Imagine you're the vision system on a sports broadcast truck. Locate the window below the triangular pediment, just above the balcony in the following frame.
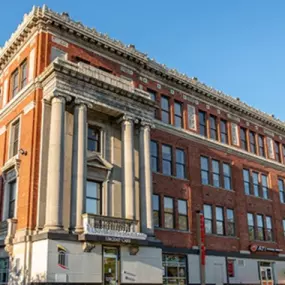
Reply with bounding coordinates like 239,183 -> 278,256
86,180 -> 101,215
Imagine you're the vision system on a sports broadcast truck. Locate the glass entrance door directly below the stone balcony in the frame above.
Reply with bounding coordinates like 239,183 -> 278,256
103,247 -> 118,285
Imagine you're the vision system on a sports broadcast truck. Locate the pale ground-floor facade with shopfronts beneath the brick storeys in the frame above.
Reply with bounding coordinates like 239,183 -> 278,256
0,235 -> 285,285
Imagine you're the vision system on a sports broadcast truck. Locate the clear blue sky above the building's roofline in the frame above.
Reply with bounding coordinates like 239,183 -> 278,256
0,0 -> 285,121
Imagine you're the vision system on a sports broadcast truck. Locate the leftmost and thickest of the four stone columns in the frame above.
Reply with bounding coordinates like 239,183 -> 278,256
45,96 -> 66,230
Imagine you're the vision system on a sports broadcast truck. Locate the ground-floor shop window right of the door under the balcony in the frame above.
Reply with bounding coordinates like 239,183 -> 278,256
162,254 -> 187,285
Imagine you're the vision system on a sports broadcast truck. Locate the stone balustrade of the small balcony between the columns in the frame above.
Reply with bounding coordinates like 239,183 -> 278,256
83,214 -> 147,240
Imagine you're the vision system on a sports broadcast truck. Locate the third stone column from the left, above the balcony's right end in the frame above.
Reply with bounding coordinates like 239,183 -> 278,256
122,116 -> 135,219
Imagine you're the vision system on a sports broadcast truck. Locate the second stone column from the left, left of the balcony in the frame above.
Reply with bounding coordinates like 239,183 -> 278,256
70,100 -> 87,232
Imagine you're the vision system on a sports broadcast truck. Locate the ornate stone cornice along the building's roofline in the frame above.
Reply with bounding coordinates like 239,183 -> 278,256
0,5 -> 285,132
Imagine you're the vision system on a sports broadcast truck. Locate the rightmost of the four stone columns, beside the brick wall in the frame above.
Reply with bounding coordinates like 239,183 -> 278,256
139,122 -> 154,236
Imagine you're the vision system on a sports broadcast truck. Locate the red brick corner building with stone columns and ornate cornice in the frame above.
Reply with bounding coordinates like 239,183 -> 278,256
0,6 -> 285,284
